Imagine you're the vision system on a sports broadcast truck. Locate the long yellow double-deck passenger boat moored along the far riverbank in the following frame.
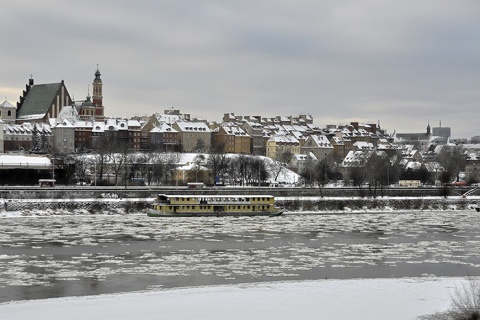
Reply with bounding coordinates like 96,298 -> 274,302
148,194 -> 284,217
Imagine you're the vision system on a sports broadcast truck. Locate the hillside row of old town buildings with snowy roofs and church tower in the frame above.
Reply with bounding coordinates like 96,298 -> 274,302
0,67 -> 473,185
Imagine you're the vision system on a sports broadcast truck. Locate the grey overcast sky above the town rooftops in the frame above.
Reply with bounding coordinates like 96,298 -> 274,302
0,0 -> 480,138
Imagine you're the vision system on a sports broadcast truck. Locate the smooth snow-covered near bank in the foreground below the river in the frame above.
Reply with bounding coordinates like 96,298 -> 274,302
0,278 -> 466,320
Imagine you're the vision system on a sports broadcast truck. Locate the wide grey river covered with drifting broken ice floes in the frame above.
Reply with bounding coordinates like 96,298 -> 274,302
0,210 -> 480,302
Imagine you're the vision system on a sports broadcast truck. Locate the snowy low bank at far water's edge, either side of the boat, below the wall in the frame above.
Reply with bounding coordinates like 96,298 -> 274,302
0,196 -> 480,216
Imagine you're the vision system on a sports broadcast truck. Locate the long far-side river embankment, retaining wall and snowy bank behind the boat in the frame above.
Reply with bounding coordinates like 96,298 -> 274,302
0,187 -> 480,214
